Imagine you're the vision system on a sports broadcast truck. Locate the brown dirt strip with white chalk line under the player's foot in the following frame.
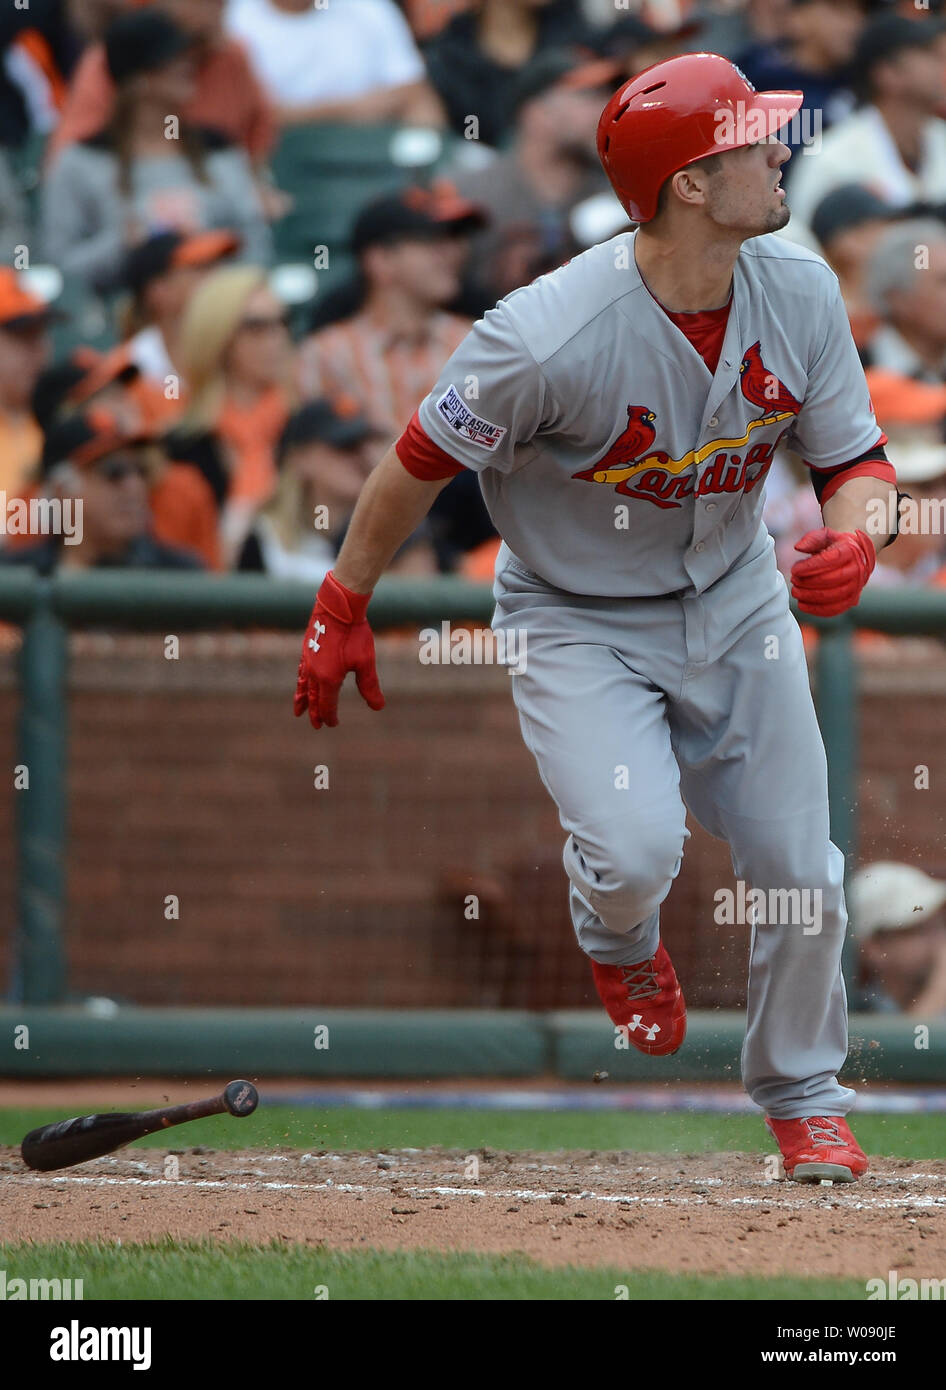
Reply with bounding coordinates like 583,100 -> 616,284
0,1148 -> 946,1279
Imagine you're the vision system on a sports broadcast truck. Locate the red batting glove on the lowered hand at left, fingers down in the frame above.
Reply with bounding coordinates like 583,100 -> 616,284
292,570 -> 385,728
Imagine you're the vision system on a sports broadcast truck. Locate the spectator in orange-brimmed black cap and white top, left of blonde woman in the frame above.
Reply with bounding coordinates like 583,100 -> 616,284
121,231 -> 240,403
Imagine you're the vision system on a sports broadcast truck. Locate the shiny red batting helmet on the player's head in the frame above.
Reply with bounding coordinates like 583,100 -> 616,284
597,53 -> 804,222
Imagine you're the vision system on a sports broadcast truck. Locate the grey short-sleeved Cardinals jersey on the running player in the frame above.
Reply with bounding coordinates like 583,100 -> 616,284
418,234 -> 881,598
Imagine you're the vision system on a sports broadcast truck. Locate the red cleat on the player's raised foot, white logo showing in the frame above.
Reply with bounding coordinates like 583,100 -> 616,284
592,941 -> 686,1056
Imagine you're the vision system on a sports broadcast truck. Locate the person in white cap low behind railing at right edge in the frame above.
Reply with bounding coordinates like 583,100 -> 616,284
847,859 -> 946,1019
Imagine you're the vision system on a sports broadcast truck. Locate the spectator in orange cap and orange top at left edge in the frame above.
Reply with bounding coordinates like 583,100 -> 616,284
0,267 -> 54,514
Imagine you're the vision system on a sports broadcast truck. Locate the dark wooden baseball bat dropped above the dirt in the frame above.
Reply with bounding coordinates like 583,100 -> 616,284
19,1081 -> 260,1173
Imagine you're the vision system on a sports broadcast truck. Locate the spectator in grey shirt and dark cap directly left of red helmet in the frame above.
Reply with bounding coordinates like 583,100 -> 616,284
454,50 -> 616,303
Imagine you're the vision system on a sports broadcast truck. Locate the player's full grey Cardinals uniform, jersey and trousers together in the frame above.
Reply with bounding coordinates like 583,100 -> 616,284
405,234 -> 882,1119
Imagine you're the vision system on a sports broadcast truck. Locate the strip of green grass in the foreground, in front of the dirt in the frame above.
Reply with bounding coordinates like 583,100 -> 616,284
0,1240 -> 865,1301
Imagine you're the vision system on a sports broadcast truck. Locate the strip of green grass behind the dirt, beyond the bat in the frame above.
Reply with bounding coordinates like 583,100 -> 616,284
0,1105 -> 946,1159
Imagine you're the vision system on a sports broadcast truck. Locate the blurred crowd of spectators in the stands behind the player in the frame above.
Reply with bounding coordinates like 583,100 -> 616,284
0,0 -> 946,585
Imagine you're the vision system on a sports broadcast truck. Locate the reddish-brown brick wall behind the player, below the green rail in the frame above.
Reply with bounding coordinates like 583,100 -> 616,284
0,634 -> 946,1008
